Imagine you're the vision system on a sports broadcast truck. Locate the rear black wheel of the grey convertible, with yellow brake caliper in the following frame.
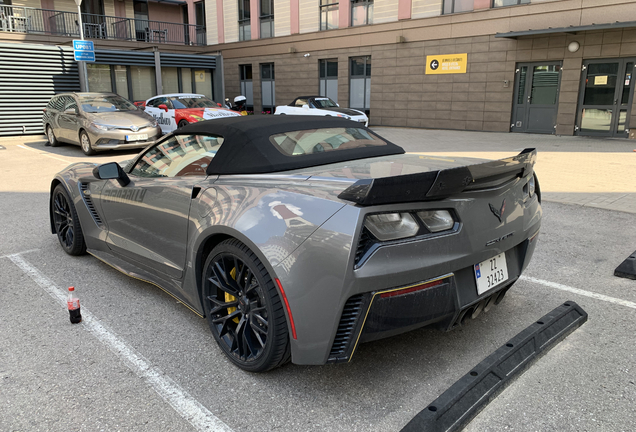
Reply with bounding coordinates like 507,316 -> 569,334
203,239 -> 290,372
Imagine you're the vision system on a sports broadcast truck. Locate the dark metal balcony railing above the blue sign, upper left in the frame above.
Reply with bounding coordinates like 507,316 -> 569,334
0,6 -> 206,45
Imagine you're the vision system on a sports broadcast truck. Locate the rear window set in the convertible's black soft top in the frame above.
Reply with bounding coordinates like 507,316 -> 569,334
269,127 -> 387,156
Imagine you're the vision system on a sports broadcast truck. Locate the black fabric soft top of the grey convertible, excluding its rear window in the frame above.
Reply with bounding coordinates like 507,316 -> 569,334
174,115 -> 404,175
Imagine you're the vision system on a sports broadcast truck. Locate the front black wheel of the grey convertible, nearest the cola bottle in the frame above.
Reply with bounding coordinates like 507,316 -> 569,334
51,184 -> 86,255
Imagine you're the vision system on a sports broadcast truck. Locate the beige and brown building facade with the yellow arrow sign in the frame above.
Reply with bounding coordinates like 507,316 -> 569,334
207,0 -> 636,138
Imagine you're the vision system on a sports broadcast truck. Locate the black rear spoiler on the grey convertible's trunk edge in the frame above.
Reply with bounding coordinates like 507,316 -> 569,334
338,148 -> 537,206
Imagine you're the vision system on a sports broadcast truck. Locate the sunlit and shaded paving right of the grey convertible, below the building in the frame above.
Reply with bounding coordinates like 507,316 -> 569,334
372,127 -> 636,213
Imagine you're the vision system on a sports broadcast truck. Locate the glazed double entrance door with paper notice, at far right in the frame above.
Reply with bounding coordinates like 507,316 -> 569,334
576,59 -> 636,138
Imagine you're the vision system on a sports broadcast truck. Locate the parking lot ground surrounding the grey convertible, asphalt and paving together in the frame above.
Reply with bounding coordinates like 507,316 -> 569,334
0,132 -> 636,432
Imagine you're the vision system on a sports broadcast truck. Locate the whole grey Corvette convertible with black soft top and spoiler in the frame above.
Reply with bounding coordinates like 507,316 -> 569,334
50,116 -> 542,372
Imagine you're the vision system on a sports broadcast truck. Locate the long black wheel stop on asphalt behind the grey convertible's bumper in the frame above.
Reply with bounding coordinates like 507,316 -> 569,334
401,301 -> 587,432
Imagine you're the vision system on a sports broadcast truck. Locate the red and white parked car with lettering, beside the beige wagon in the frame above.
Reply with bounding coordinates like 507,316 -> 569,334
143,93 -> 241,134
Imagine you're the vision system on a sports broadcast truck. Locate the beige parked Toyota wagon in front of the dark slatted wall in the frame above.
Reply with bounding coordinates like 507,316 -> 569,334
42,93 -> 161,155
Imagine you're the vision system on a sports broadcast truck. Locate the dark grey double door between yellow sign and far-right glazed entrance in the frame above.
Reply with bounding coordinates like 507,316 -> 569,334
511,62 -> 561,134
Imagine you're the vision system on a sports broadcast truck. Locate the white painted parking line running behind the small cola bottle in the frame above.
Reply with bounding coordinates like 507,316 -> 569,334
7,254 -> 232,432
